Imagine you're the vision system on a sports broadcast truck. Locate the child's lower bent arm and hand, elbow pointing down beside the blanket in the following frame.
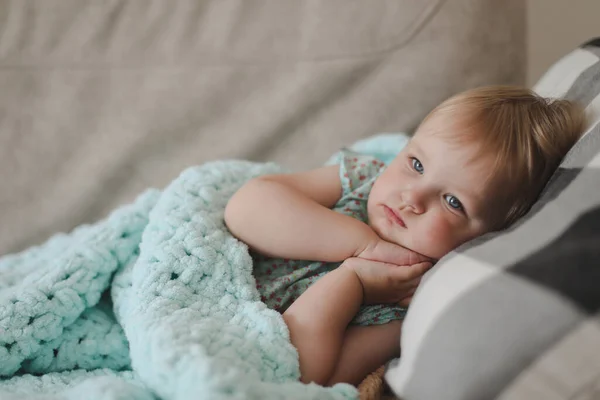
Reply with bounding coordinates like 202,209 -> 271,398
283,258 -> 431,385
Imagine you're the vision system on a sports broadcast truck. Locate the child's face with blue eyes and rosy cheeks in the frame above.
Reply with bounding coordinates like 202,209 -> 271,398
367,112 -> 499,259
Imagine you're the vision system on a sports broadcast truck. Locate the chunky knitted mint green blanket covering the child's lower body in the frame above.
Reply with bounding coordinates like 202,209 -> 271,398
0,135 -> 408,400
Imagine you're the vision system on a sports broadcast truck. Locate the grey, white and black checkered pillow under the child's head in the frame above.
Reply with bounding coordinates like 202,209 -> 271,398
386,38 -> 600,400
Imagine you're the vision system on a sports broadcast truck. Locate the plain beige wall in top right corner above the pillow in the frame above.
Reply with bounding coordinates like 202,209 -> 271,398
527,0 -> 600,85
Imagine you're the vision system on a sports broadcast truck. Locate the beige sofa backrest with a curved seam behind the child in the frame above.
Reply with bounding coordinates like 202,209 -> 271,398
0,0 -> 525,254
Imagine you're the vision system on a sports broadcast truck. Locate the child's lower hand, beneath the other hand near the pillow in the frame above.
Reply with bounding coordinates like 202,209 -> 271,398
341,258 -> 432,305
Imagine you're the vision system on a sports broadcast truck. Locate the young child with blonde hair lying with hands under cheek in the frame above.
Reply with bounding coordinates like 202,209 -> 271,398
225,86 -> 583,384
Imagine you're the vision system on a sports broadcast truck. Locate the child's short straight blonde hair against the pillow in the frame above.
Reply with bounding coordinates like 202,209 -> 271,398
424,86 -> 584,229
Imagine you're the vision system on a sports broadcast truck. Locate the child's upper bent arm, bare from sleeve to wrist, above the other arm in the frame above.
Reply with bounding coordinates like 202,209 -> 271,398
225,165 -> 378,261
